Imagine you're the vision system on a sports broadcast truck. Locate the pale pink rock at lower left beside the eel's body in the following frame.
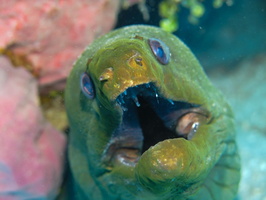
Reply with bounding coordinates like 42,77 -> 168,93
0,56 -> 66,200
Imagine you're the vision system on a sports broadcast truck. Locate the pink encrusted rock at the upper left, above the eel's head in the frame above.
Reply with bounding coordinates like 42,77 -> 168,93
0,0 -> 120,85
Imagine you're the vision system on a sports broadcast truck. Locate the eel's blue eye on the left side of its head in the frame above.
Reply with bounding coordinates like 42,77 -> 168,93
80,72 -> 95,99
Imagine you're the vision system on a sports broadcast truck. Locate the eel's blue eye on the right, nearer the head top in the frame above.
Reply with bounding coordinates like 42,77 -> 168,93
148,38 -> 170,65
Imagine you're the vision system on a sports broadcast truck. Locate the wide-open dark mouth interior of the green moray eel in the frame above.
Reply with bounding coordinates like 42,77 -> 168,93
104,83 -> 208,166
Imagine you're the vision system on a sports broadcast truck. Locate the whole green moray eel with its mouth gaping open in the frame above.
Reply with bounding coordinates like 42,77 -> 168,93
65,25 -> 240,200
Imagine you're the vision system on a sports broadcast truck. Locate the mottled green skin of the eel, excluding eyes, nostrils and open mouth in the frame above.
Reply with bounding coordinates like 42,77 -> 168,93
65,26 -> 240,200
